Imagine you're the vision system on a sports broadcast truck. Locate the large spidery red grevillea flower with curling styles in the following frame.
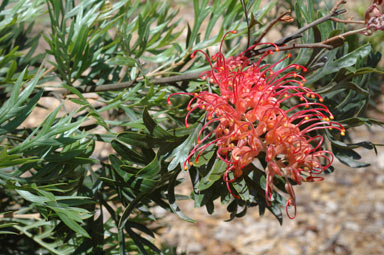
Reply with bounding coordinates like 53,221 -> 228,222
168,31 -> 345,218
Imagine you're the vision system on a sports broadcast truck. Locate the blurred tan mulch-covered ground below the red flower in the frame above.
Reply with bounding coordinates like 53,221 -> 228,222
160,127 -> 384,255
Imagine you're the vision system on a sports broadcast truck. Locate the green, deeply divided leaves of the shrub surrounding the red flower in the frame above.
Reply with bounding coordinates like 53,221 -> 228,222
0,0 -> 383,255
